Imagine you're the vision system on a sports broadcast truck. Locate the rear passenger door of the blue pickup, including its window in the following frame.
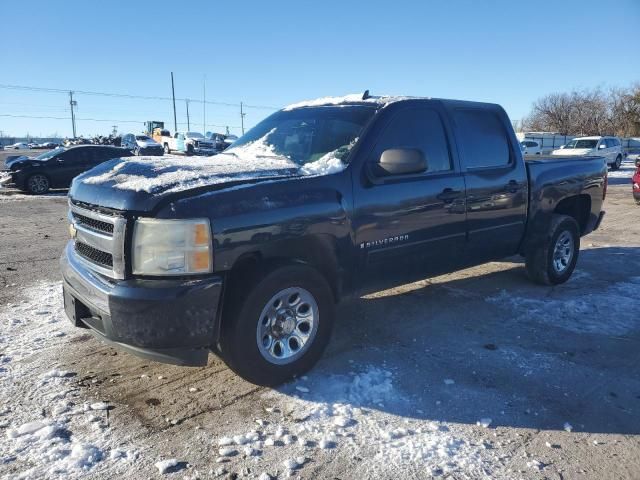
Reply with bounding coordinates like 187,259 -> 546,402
452,107 -> 528,264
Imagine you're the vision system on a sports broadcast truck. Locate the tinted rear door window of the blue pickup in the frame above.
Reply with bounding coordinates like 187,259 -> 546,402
454,110 -> 511,168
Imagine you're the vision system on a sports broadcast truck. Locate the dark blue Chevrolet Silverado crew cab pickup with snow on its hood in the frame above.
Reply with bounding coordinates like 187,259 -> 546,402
61,92 -> 607,385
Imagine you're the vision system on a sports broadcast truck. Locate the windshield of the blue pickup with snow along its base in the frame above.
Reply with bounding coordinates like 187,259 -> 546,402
224,106 -> 375,165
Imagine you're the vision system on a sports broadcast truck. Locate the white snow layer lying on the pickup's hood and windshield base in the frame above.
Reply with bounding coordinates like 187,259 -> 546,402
82,132 -> 355,193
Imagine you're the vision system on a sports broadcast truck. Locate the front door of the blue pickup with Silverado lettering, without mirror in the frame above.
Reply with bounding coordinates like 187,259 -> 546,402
353,102 -> 465,284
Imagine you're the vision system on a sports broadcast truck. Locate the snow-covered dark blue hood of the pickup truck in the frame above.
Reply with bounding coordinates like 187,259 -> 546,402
69,132 -> 346,212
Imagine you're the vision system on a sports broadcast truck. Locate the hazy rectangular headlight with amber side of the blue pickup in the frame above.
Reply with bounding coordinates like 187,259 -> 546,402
133,218 -> 213,275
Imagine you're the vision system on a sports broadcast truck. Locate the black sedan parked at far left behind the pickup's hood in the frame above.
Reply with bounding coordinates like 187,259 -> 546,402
0,145 -> 131,194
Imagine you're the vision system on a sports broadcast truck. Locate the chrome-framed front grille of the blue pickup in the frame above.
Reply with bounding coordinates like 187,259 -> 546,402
69,202 -> 127,279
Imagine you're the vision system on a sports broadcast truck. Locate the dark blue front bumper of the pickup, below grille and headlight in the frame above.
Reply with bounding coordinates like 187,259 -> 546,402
60,242 -> 222,366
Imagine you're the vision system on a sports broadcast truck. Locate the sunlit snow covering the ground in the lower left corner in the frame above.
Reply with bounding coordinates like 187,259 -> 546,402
0,284 -> 137,479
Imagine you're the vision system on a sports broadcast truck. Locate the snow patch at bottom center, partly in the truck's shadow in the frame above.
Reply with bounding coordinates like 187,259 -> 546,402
263,366 -> 492,478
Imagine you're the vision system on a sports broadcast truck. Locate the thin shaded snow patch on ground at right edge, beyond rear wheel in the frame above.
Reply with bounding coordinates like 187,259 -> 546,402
486,277 -> 640,335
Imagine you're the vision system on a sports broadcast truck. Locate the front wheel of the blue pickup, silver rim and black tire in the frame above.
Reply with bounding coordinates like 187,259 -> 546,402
220,265 -> 335,386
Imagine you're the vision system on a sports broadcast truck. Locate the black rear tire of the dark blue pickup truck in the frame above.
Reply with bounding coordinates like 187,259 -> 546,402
525,215 -> 580,285
